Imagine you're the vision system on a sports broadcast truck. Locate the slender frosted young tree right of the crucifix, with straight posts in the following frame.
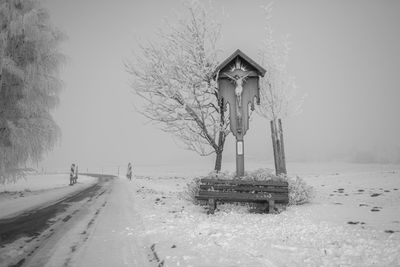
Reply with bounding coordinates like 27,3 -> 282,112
256,3 -> 304,175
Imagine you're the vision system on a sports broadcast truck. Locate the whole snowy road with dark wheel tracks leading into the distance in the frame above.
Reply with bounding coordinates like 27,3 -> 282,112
0,176 -> 156,266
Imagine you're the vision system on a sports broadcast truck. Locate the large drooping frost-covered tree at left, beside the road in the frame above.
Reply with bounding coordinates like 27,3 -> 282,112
0,0 -> 63,183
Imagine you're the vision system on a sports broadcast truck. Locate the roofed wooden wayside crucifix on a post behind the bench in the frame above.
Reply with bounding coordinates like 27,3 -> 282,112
214,49 -> 265,177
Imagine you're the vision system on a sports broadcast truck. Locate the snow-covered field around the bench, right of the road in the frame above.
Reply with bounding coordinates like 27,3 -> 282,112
130,164 -> 400,266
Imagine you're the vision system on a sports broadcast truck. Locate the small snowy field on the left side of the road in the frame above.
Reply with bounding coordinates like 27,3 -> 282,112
0,173 -> 97,219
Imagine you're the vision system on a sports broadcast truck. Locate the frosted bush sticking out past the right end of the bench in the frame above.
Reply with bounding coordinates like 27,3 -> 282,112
287,176 -> 314,205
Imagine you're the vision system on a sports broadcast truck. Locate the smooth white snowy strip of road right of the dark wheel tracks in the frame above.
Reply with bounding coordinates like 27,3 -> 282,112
71,178 -> 151,267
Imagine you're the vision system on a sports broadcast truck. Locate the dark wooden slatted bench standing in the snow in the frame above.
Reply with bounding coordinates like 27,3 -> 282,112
196,178 -> 289,214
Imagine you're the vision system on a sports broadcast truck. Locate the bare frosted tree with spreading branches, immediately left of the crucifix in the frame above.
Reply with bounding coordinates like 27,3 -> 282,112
126,2 -> 229,171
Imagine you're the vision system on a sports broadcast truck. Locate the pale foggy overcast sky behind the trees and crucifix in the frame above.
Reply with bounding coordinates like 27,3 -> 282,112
39,0 -> 400,174
